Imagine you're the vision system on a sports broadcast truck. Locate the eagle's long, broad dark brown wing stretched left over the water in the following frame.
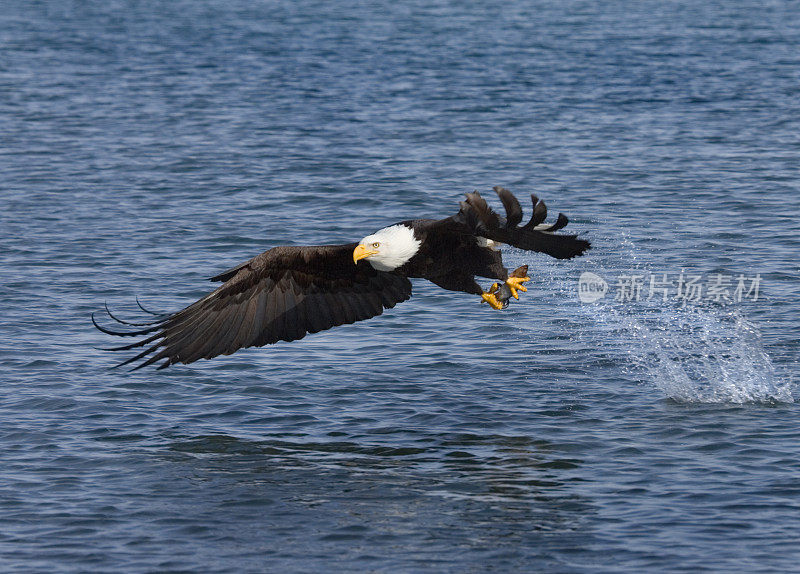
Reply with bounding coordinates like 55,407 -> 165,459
92,243 -> 411,369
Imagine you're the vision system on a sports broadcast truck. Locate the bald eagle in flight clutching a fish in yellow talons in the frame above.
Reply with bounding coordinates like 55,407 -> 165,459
97,187 -> 590,369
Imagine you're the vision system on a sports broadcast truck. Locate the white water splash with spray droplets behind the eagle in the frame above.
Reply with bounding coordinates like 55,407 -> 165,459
560,227 -> 796,404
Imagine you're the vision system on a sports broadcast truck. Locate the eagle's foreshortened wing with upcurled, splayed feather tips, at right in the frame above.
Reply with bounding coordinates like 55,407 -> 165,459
449,186 -> 591,259
